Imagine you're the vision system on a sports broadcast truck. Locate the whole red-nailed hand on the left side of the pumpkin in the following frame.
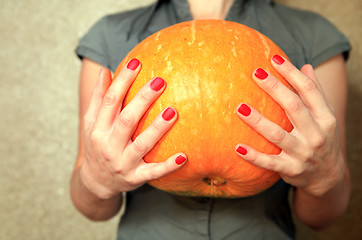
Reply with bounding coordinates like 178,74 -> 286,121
80,59 -> 186,199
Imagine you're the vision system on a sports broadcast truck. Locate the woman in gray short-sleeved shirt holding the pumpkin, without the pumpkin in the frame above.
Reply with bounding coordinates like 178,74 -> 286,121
71,0 -> 350,239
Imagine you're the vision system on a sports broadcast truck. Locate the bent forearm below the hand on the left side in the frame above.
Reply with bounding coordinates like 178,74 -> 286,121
71,163 -> 122,221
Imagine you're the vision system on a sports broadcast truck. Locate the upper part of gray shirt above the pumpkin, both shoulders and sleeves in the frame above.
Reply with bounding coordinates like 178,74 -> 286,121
76,0 -> 350,72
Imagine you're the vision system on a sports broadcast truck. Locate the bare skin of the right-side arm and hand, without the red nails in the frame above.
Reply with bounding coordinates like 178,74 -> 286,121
238,55 -> 351,229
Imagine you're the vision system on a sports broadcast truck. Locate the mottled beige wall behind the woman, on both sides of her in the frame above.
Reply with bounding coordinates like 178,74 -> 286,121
0,0 -> 362,240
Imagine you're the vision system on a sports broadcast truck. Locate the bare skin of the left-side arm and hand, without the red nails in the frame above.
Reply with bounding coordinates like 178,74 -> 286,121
71,59 -> 186,220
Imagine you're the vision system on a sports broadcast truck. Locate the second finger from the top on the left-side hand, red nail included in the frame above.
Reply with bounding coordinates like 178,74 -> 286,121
112,77 -> 166,147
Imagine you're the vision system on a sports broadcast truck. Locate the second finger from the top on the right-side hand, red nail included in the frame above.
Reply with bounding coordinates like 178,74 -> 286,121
253,68 -> 319,139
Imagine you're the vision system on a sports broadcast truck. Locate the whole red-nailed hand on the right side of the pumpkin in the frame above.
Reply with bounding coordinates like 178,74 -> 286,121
236,55 -> 346,196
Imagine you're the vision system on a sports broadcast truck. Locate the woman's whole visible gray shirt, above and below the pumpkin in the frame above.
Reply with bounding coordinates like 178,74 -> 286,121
76,0 -> 350,240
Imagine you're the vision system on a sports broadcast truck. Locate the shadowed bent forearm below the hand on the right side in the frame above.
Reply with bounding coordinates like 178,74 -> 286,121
293,155 -> 351,230
